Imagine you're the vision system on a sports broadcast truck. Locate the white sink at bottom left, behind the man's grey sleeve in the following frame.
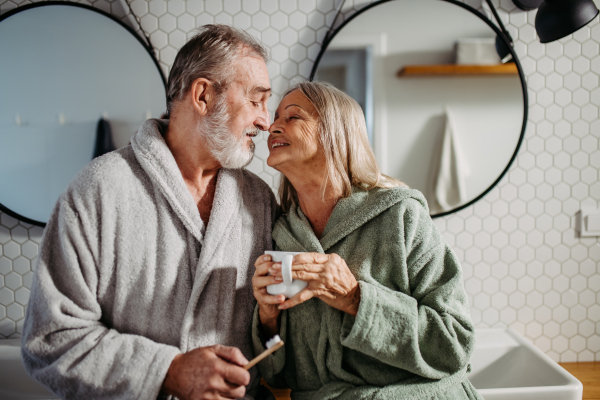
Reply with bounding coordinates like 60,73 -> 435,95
0,339 -> 58,400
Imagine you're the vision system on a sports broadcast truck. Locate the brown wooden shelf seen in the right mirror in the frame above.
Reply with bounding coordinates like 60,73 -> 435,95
397,63 -> 519,78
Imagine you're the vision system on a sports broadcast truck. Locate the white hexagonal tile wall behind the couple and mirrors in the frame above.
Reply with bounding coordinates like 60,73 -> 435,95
0,0 -> 600,361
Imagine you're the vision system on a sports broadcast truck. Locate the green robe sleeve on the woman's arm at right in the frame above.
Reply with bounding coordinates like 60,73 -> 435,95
341,200 -> 475,379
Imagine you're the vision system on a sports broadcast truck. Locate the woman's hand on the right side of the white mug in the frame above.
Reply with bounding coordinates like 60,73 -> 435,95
269,253 -> 360,316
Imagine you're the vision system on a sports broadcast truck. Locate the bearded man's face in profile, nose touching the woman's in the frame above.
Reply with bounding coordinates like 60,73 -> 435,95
224,53 -> 271,150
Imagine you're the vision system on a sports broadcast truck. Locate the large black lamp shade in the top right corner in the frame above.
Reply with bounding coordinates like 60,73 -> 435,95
535,0 -> 598,43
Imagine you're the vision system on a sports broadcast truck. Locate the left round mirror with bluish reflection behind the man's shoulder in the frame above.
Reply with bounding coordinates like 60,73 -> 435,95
0,2 -> 166,226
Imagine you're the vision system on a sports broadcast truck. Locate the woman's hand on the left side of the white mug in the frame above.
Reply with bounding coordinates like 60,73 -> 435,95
252,255 -> 285,337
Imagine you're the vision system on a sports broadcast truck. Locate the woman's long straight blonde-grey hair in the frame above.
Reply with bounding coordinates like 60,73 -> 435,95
279,82 -> 405,212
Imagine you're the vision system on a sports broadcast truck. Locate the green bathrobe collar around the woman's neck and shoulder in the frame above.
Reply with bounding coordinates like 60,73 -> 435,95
273,186 -> 429,253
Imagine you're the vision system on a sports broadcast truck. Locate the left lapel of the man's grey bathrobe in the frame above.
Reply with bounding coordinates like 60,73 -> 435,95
131,119 -> 204,244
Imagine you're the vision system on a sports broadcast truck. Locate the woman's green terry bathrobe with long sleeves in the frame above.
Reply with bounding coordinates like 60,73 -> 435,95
252,187 -> 482,400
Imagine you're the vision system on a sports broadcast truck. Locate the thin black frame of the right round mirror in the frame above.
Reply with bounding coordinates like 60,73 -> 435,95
309,0 -> 529,218
